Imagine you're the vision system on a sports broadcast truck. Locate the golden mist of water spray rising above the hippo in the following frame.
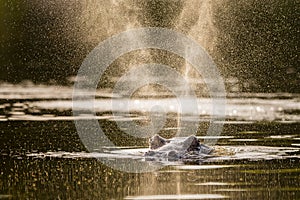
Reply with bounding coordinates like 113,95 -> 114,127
78,0 -> 218,91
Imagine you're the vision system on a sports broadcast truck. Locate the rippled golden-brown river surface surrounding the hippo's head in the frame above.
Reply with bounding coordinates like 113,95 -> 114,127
0,84 -> 300,199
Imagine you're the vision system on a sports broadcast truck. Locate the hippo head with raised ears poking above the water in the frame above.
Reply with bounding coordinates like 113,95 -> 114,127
144,134 -> 214,160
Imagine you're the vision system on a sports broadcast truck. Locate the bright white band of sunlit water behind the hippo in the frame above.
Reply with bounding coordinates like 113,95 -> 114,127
0,85 -> 300,122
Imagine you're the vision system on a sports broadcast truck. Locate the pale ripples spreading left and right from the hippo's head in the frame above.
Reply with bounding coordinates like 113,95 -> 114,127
27,144 -> 300,164
